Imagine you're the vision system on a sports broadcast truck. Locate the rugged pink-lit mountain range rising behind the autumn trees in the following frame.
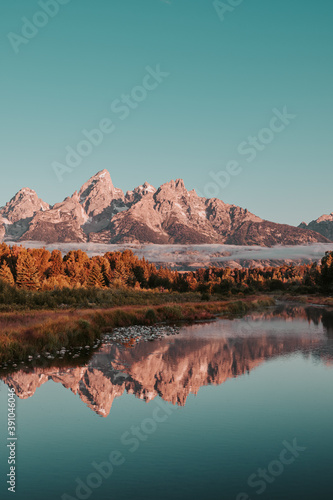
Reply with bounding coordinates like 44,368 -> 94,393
0,170 -> 333,247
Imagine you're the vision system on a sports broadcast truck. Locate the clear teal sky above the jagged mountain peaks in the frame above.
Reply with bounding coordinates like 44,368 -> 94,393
0,0 -> 333,224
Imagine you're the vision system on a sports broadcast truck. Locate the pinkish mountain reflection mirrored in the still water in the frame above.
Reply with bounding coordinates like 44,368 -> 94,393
1,305 -> 333,417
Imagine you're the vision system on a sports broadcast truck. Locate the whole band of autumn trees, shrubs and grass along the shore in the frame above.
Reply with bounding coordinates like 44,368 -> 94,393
0,243 -> 333,369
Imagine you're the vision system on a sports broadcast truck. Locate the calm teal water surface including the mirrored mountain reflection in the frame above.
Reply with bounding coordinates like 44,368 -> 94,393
0,306 -> 333,500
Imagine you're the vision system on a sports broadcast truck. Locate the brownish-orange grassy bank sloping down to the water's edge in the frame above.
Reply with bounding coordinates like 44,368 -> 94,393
0,294 -> 275,364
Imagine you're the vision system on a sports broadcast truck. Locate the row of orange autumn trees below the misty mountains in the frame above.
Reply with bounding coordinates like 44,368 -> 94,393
0,243 -> 333,295
